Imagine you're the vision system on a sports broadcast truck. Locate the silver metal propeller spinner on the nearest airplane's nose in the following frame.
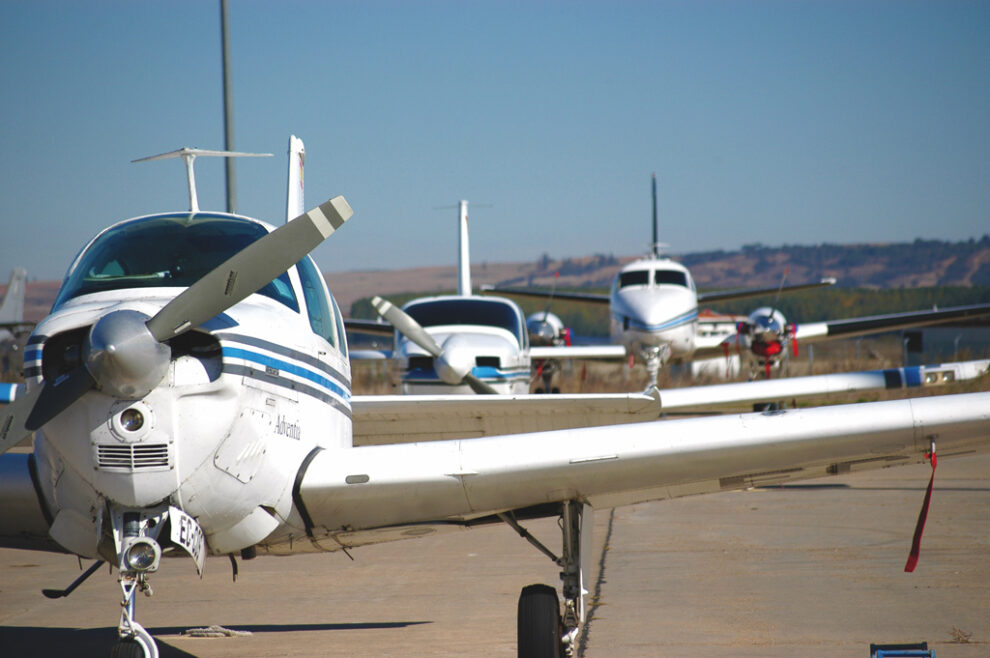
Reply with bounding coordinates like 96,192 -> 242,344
86,310 -> 171,399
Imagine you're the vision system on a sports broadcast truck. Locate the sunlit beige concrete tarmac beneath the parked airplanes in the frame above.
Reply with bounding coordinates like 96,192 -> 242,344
0,456 -> 990,658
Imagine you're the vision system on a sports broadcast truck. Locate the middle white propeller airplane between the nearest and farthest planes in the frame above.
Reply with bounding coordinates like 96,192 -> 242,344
345,201 -> 625,395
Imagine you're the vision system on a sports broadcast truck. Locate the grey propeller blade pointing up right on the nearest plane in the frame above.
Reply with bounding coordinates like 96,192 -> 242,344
148,196 -> 354,342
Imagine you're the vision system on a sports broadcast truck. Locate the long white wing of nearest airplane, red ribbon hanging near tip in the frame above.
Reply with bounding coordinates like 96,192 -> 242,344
294,393 -> 990,550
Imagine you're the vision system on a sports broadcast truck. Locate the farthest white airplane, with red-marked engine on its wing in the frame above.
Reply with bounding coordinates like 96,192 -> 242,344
483,175 -> 990,386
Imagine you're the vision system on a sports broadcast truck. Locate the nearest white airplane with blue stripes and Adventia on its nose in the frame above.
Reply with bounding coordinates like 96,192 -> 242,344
0,149 -> 990,657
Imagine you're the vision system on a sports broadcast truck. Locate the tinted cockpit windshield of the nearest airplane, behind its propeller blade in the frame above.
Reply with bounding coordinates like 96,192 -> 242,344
55,214 -> 299,313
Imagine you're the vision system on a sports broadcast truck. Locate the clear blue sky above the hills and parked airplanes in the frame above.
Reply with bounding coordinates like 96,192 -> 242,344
0,0 -> 990,279
